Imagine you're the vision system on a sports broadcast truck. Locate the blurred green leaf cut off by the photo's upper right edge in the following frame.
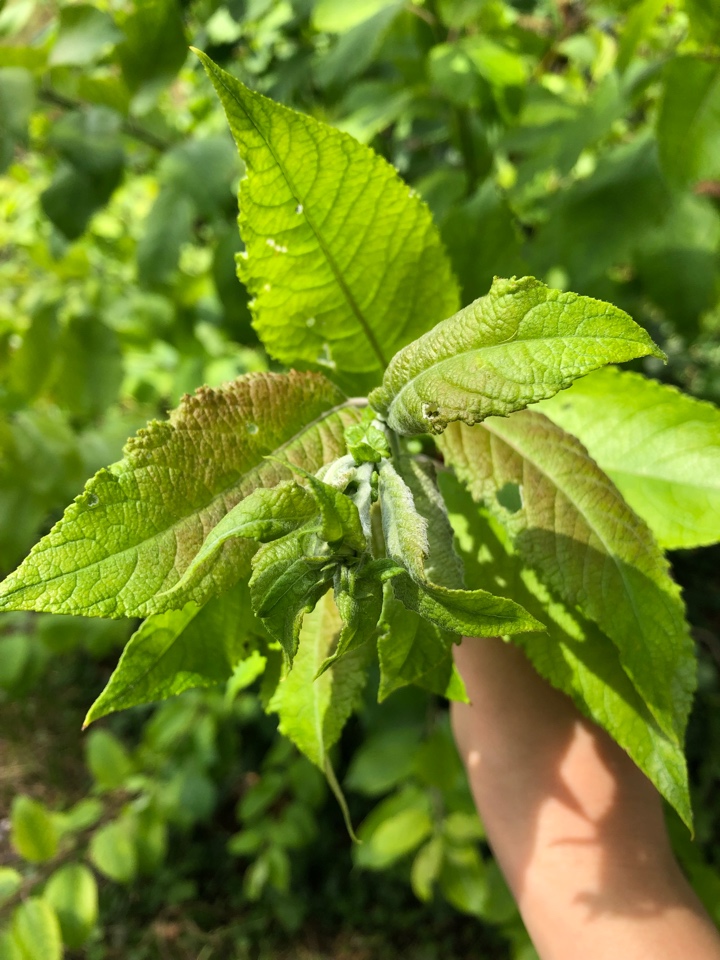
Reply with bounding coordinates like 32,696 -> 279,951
657,57 -> 720,184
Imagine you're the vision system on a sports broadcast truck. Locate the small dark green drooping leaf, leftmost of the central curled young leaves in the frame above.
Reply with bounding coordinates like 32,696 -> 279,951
250,530 -> 336,663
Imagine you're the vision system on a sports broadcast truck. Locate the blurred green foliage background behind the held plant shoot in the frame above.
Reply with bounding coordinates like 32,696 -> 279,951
0,0 -> 720,960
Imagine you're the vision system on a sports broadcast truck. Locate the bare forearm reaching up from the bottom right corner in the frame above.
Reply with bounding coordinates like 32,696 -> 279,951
452,637 -> 720,960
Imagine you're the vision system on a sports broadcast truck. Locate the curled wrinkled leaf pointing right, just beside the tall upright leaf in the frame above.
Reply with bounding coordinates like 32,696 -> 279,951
370,277 -> 665,435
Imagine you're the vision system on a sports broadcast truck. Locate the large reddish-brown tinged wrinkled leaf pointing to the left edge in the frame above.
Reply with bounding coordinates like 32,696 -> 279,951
0,373 -> 359,617
